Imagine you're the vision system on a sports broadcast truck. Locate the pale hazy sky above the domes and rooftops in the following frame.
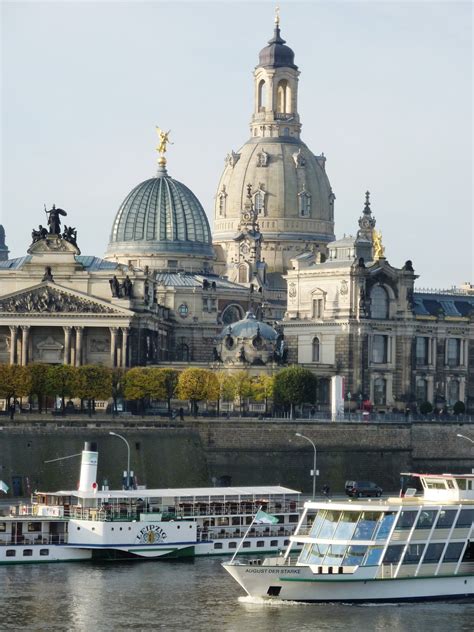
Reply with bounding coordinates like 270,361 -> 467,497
0,0 -> 474,288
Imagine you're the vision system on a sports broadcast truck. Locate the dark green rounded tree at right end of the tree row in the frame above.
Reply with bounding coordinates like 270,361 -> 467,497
273,366 -> 317,419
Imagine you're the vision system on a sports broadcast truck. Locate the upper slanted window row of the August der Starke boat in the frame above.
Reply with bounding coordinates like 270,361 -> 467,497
310,509 -> 474,540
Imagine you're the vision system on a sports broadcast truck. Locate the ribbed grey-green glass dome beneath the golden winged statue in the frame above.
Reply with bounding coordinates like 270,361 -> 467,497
107,166 -> 214,257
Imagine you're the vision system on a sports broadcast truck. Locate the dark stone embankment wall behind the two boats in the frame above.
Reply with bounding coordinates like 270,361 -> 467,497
0,415 -> 474,495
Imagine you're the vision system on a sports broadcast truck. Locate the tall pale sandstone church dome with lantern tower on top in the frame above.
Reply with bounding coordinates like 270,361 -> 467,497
214,16 -> 335,318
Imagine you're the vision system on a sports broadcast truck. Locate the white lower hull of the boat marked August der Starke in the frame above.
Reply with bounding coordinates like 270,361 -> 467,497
223,564 -> 474,602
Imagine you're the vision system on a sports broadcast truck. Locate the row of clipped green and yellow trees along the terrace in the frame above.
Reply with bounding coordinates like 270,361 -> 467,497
0,364 -> 317,414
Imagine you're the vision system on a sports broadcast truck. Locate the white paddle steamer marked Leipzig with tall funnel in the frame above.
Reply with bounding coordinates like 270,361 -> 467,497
0,443 -> 301,564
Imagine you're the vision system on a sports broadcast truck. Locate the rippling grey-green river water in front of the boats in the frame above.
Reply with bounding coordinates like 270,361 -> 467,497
0,558 -> 474,632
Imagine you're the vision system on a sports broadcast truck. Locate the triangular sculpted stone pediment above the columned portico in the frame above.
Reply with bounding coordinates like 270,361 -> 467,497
0,282 -> 133,316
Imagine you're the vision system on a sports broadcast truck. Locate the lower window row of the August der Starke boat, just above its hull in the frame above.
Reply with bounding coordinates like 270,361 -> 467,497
299,542 -> 473,566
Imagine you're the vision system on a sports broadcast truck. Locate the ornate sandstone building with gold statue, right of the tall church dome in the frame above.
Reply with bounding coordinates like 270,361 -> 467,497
283,198 -> 474,411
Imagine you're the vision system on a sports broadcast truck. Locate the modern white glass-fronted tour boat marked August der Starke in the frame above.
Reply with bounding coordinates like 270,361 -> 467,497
223,473 -> 474,602
